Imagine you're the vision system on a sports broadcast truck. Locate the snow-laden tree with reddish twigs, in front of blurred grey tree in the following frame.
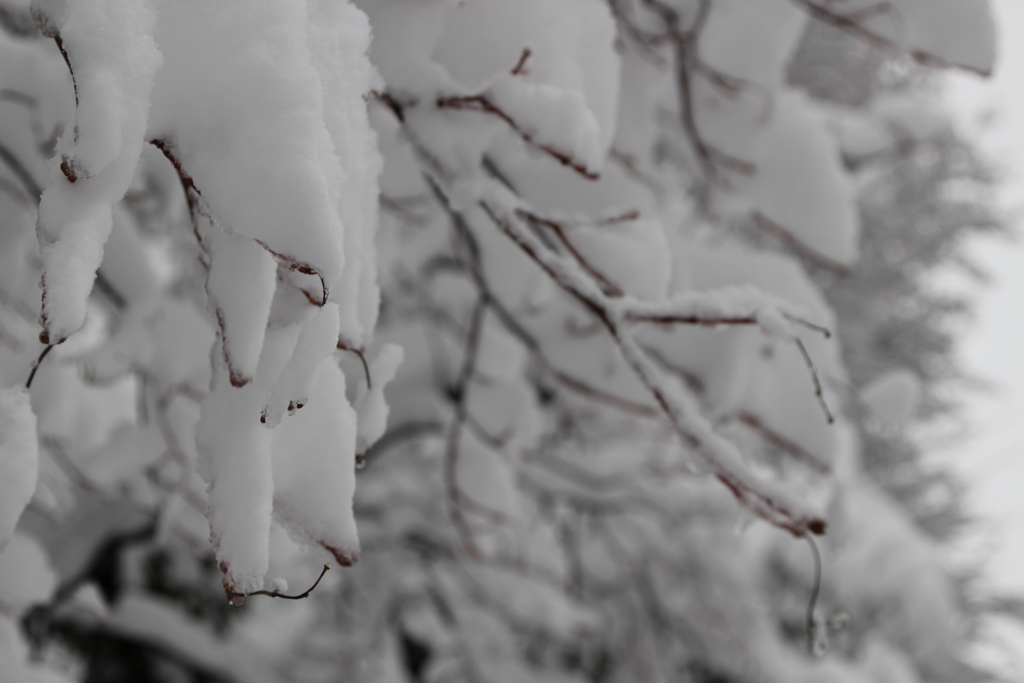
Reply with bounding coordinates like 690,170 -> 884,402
0,0 -> 995,683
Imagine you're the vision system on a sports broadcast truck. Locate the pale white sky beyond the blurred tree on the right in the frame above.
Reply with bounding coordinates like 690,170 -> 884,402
949,0 -> 1024,680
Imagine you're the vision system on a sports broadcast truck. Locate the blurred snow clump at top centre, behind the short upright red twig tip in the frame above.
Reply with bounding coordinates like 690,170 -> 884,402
433,0 -> 620,163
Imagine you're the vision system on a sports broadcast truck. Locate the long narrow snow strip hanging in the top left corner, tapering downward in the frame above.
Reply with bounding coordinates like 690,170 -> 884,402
38,0 -> 161,343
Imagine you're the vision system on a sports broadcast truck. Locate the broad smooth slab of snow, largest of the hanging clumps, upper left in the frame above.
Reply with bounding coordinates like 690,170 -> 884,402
146,0 -> 348,291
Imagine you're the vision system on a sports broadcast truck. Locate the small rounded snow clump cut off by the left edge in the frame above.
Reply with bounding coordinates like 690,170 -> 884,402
0,388 -> 39,553
